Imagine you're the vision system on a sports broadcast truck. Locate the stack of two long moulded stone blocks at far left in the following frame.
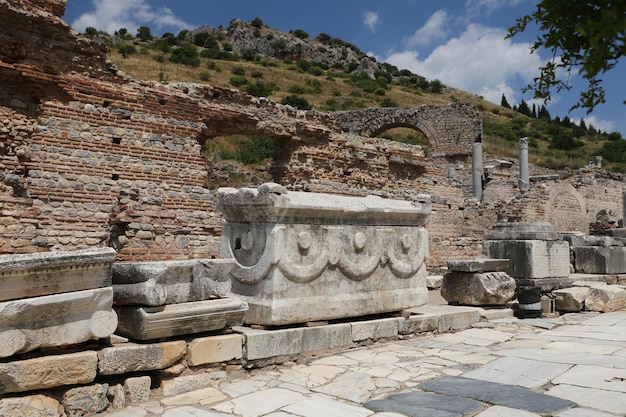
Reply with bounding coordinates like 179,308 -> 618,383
0,248 -> 117,358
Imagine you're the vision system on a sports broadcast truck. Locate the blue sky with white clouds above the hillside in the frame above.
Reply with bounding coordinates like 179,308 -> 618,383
64,0 -> 626,138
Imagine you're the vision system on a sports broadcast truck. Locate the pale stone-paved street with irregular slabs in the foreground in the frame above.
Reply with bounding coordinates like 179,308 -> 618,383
99,311 -> 626,417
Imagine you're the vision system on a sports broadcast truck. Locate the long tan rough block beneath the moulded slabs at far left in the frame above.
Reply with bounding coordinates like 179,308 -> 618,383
0,351 -> 98,394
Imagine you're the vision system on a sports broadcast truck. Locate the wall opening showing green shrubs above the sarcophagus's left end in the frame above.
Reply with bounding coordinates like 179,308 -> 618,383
201,135 -> 278,189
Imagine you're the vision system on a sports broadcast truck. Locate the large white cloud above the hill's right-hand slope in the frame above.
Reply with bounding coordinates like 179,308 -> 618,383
386,24 -> 541,104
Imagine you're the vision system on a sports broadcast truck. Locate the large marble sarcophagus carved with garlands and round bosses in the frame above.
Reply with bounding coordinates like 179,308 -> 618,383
218,184 -> 431,325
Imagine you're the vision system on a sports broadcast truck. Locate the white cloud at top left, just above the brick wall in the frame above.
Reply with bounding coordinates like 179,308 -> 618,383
72,0 -> 191,35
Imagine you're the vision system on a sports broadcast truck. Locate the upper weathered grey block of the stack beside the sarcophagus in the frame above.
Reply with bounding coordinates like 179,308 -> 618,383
113,259 -> 235,306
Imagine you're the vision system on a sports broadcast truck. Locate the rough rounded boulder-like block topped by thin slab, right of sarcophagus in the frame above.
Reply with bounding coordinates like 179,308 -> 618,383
441,259 -> 516,306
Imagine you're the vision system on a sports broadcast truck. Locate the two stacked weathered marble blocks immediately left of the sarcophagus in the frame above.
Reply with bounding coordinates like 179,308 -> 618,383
113,259 -> 248,340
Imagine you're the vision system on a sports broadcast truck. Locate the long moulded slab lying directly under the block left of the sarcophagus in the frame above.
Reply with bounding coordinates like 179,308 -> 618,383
116,297 -> 248,340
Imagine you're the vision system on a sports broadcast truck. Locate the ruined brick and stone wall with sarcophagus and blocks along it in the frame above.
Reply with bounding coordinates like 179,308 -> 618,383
0,0 -> 626,415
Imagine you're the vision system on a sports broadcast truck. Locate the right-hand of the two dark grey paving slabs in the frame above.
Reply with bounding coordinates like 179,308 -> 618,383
419,376 -> 576,414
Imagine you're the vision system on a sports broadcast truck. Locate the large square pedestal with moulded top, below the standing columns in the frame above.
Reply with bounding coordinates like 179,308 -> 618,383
485,223 -> 570,290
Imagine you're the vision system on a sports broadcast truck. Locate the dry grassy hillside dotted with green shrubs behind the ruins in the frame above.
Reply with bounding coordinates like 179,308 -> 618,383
86,18 -> 626,172
